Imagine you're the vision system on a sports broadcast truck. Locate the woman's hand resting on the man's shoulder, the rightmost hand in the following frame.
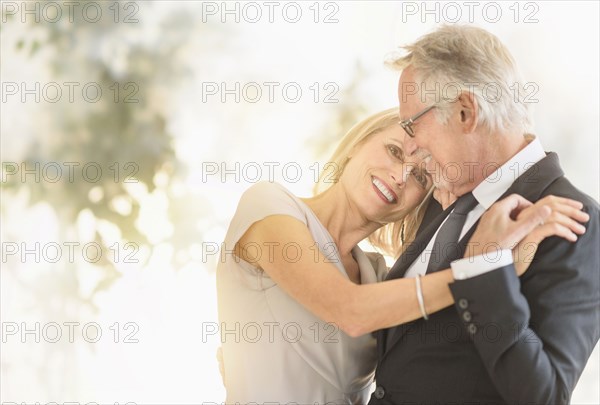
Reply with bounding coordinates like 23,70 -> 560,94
512,196 -> 590,276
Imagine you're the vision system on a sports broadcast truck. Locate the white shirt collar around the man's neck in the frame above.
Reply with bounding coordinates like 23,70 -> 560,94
473,134 -> 546,210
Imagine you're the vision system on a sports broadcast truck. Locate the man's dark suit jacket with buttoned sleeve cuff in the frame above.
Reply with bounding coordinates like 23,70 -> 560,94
369,153 -> 600,405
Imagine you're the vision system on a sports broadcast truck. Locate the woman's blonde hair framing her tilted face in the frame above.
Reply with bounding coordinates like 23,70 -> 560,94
313,108 -> 433,258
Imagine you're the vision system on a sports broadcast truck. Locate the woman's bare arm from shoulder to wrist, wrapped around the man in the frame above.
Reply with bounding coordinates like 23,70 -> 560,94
238,215 -> 453,336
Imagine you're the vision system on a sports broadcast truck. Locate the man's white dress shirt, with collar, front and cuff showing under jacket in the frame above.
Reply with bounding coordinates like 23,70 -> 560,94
404,135 -> 546,280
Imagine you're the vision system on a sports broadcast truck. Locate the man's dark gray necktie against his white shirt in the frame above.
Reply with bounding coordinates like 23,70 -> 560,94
427,193 -> 477,273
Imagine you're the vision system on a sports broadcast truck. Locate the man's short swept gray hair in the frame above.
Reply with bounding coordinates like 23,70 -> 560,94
387,25 -> 532,133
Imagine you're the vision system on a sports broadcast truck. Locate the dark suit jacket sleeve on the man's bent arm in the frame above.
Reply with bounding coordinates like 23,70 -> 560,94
450,202 -> 600,404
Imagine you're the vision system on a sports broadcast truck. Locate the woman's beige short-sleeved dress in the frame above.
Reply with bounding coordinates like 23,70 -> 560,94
217,182 -> 387,404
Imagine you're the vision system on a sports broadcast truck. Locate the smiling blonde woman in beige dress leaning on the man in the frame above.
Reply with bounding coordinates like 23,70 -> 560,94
217,109 -> 576,404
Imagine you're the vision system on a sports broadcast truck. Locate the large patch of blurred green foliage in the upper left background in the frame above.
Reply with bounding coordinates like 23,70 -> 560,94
2,2 -> 202,298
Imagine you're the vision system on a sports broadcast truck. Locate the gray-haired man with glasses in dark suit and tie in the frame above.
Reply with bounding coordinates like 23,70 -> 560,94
370,26 -> 600,404
